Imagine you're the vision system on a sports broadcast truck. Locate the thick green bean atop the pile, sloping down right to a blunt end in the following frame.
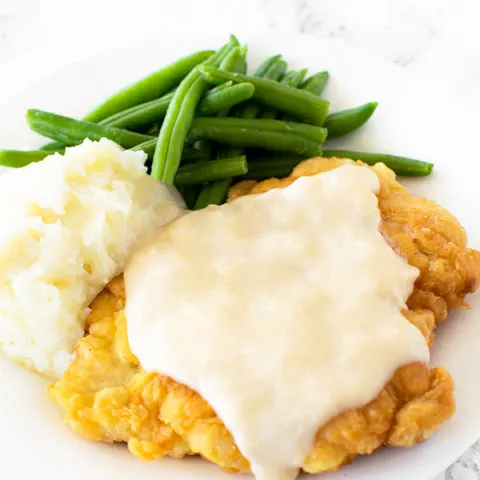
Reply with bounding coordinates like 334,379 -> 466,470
199,65 -> 329,125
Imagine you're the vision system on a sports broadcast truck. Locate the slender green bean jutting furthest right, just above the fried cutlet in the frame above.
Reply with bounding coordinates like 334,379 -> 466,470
323,150 -> 433,177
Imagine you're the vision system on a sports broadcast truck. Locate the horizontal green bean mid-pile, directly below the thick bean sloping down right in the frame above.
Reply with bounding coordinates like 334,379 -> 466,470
187,117 -> 327,143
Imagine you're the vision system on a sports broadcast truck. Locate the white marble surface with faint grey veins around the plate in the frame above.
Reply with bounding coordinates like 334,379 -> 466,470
0,0 -> 480,480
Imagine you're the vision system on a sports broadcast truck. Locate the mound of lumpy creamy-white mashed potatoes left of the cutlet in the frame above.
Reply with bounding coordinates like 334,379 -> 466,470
0,140 -> 182,377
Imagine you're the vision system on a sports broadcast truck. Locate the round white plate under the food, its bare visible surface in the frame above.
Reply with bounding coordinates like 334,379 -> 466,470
0,27 -> 480,480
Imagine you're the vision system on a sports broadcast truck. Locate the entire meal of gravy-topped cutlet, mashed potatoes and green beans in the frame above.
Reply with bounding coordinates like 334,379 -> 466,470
0,36 -> 480,480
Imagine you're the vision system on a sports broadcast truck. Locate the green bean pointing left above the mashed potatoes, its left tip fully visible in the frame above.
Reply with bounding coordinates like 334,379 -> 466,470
27,110 -> 153,148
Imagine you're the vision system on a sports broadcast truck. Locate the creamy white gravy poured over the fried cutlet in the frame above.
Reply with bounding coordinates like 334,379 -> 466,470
125,165 -> 429,480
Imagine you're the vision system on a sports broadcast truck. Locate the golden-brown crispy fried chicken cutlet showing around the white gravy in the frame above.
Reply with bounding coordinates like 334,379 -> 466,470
49,158 -> 480,473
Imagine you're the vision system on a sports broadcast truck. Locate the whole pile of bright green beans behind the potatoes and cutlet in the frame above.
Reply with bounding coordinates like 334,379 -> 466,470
0,35 -> 433,209
